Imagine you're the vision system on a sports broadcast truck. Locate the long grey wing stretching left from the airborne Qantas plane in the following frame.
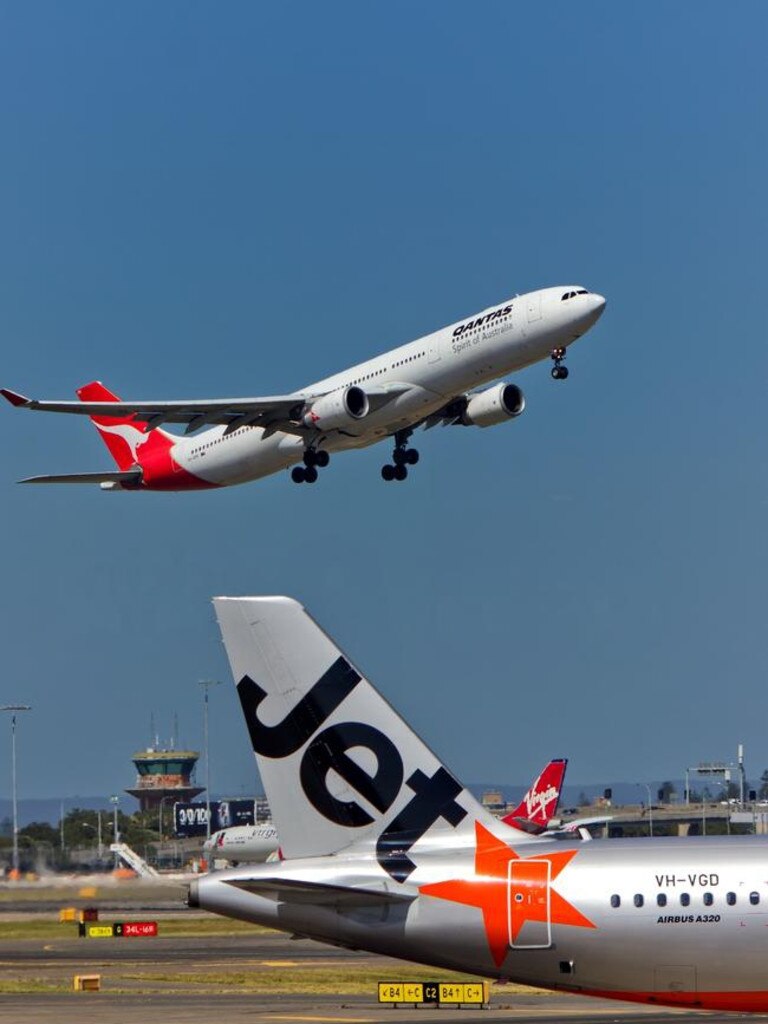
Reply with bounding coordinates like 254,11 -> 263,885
0,384 -> 410,435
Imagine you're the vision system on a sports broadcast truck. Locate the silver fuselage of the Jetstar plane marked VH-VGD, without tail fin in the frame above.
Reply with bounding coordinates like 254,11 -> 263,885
193,837 -> 768,1012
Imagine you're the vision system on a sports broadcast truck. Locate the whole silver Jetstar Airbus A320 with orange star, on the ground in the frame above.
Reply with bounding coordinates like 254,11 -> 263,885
187,597 -> 768,1013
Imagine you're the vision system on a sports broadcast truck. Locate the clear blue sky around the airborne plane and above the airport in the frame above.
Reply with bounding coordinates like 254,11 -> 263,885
0,2 -> 768,797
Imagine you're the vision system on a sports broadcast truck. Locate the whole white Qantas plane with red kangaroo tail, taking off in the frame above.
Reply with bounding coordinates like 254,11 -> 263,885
0,285 -> 605,490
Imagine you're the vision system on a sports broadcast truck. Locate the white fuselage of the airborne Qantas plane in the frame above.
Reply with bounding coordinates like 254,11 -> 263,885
171,286 -> 605,486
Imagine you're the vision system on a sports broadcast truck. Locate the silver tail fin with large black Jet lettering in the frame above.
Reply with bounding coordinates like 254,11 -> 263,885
214,597 -> 536,882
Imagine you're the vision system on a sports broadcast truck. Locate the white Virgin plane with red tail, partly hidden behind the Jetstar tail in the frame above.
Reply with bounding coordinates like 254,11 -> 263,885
203,758 -> 568,865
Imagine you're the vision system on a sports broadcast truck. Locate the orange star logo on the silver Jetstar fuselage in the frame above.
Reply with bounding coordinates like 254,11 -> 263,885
419,821 -> 596,967
